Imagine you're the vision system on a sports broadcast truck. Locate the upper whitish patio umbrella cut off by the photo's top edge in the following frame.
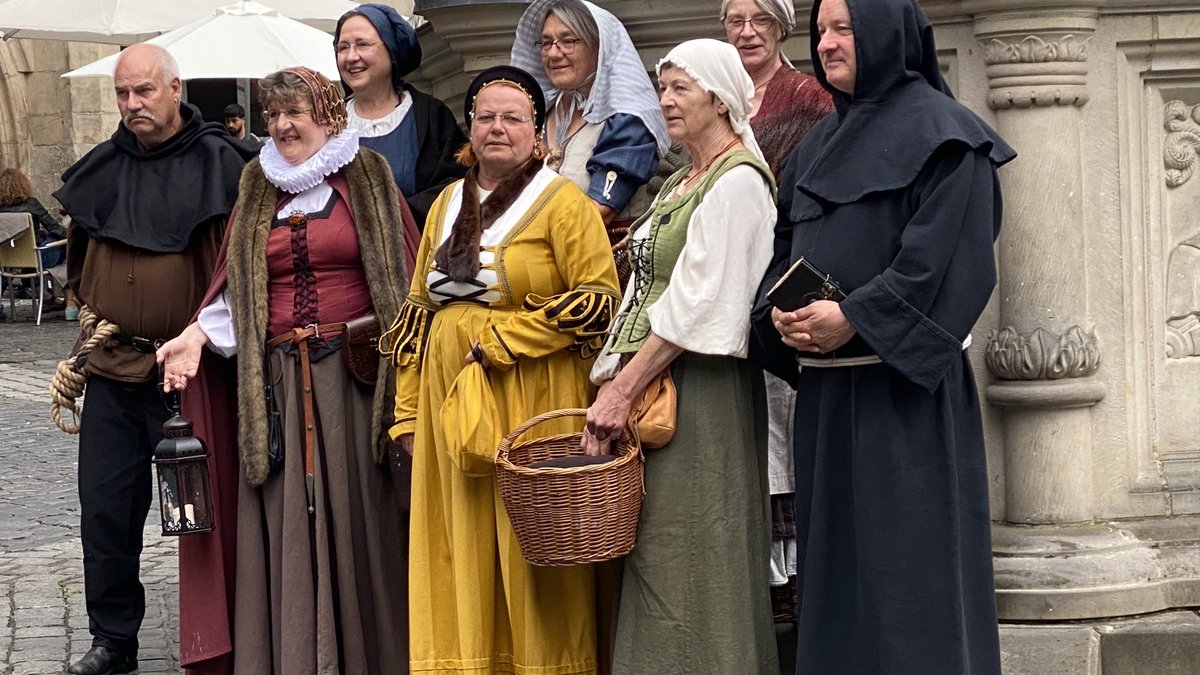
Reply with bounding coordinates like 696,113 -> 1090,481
0,0 -> 358,44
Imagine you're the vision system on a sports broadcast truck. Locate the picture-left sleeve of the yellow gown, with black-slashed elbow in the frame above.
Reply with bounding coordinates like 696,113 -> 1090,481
379,190 -> 451,441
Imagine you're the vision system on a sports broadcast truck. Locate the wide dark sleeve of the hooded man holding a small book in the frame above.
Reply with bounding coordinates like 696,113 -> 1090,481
841,144 -> 1002,392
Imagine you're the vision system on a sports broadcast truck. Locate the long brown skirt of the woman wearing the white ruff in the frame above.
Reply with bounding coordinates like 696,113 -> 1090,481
234,348 -> 408,675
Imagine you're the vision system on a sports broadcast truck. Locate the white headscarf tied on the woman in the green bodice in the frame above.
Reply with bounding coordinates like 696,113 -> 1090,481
654,37 -> 767,161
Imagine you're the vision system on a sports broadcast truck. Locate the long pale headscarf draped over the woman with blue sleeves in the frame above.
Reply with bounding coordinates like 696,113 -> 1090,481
510,0 -> 671,155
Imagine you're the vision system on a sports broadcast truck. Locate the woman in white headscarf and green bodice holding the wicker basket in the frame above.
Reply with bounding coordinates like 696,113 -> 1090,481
582,40 -> 779,675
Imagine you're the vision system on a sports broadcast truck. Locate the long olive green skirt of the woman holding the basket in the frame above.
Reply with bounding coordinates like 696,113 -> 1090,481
613,353 -> 779,675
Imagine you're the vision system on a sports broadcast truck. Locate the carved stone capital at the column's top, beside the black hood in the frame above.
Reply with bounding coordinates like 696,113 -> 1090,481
976,8 -> 1097,109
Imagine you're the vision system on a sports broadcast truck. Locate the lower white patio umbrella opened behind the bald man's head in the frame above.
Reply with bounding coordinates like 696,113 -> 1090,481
62,1 -> 338,80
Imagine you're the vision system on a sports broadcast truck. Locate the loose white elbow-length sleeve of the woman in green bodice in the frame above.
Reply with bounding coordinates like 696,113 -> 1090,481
647,165 -> 776,358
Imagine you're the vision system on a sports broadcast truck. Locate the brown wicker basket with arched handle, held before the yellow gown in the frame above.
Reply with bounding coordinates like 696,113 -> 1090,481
496,408 -> 643,566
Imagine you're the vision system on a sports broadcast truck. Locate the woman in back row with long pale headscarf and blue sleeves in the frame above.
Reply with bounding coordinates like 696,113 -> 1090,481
511,0 -> 671,227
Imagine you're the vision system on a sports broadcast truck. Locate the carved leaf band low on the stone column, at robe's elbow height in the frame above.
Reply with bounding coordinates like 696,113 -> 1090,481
985,325 -> 1100,381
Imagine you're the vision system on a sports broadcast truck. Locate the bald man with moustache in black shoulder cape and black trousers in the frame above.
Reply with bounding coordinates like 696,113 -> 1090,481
54,44 -> 253,675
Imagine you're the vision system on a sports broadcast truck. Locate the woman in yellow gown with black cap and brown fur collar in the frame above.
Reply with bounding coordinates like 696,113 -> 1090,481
383,66 -> 619,675
